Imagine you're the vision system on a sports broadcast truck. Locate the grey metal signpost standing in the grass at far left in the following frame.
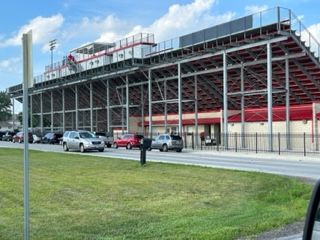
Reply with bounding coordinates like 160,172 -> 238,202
22,31 -> 33,240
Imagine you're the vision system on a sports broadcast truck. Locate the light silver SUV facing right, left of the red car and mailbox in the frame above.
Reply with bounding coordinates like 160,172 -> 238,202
62,131 -> 105,152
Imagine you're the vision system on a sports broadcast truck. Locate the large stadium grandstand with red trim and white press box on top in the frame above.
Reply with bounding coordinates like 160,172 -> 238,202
8,7 -> 320,151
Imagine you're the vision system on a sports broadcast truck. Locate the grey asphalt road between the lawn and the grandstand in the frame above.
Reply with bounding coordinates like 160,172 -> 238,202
0,141 -> 320,180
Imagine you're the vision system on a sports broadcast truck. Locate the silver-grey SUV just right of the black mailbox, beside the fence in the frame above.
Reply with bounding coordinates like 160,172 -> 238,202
149,134 -> 183,152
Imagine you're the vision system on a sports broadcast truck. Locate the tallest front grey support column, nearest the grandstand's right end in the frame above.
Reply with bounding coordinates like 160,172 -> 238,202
267,43 -> 273,152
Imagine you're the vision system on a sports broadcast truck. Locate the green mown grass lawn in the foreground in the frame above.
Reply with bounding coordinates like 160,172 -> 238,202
0,148 -> 311,240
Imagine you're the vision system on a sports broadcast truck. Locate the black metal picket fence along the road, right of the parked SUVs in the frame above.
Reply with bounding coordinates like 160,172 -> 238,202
143,132 -> 320,156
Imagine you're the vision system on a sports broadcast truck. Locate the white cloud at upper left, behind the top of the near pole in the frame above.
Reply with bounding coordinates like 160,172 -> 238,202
0,14 -> 64,47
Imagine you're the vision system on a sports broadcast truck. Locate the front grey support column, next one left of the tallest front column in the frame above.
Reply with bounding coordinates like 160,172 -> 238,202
222,51 -> 228,148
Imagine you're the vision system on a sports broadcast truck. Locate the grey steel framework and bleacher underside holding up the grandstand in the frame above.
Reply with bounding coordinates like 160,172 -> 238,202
9,8 -> 320,151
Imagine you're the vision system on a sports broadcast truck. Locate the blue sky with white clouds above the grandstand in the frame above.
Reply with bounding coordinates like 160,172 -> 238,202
0,0 -> 320,93
